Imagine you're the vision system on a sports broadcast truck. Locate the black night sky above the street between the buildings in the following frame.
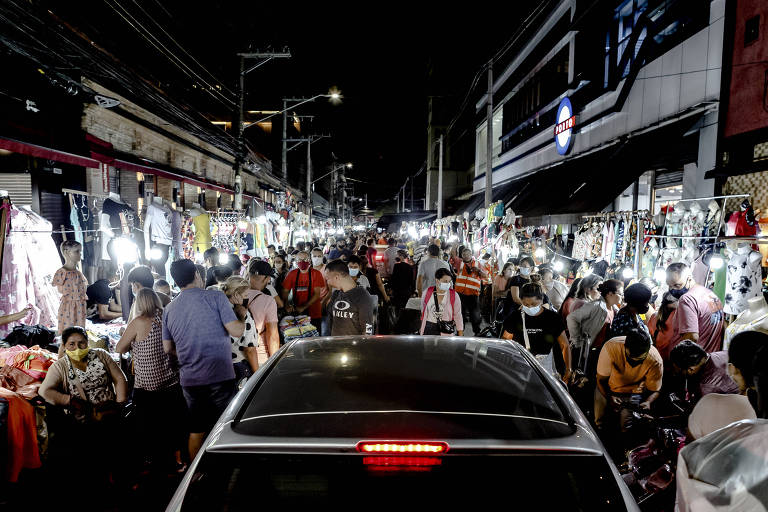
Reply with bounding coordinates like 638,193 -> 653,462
44,0 -> 539,206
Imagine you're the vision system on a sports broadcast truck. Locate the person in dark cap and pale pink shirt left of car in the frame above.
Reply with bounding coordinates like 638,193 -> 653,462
245,259 -> 280,366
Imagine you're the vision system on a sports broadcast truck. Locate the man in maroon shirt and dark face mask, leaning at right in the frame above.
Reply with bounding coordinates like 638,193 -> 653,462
667,263 -> 725,353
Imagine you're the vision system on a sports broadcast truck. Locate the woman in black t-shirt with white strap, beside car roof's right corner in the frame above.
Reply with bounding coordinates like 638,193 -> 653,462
502,283 -> 571,383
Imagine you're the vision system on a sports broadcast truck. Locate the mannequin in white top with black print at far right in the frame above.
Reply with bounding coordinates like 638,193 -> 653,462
723,242 -> 762,315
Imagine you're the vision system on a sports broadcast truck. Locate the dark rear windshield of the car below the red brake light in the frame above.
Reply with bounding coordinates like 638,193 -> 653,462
182,453 -> 626,512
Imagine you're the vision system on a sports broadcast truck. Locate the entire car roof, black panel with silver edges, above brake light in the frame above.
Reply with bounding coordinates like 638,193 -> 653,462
209,336 -> 602,453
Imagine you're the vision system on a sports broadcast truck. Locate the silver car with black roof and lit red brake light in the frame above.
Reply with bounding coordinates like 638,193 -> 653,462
168,336 -> 638,512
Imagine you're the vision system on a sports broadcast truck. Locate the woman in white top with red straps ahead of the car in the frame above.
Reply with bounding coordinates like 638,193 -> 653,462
419,268 -> 464,336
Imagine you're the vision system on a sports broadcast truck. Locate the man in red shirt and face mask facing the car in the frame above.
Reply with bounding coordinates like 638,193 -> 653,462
282,251 -> 326,332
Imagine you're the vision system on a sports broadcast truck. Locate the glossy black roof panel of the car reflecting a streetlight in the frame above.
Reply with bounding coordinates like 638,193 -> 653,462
234,337 -> 574,439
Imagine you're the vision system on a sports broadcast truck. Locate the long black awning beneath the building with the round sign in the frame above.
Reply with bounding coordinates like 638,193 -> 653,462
501,117 -> 698,225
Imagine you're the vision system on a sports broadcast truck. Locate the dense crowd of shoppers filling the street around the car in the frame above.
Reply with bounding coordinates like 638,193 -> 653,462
33,232 -> 768,508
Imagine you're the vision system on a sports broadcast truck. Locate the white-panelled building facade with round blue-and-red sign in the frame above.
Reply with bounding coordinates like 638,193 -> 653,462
473,0 -> 726,223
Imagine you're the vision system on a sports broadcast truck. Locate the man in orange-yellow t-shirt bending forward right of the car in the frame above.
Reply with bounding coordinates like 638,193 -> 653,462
595,329 -> 664,433
